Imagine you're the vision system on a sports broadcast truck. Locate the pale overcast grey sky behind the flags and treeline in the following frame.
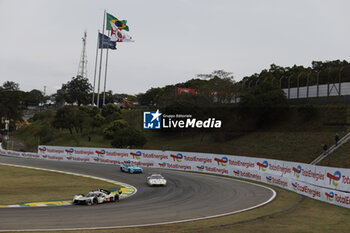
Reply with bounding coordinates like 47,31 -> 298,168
0,0 -> 350,94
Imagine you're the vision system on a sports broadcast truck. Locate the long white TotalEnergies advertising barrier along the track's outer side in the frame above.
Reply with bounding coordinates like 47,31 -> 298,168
0,145 -> 350,208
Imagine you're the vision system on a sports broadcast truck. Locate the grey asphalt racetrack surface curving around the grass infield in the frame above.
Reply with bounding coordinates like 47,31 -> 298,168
0,156 -> 274,231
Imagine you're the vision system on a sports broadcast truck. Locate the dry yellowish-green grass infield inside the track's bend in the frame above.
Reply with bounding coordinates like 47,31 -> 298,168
0,165 -> 118,205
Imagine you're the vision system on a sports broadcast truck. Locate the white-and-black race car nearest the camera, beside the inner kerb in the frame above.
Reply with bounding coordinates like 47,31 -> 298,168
73,189 -> 122,205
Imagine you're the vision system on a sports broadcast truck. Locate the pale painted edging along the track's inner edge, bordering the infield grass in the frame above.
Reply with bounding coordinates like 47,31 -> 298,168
0,163 -> 137,208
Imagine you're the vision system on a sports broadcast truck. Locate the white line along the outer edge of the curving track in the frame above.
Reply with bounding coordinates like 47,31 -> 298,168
0,168 -> 277,232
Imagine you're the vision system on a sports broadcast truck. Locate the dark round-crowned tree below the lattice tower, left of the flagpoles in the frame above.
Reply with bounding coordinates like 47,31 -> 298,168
61,75 -> 92,106
